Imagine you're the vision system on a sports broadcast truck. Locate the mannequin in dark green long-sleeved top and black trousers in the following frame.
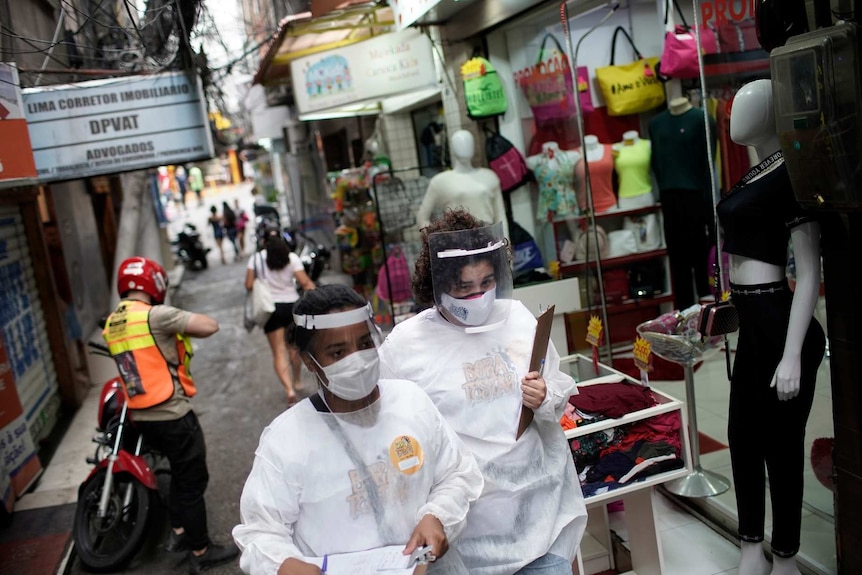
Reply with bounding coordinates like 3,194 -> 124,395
649,97 -> 716,309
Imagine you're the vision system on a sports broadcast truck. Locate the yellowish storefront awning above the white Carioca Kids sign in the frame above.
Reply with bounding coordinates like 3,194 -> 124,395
253,0 -> 395,85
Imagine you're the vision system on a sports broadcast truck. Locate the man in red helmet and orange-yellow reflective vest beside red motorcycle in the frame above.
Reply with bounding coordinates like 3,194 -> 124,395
103,257 -> 238,575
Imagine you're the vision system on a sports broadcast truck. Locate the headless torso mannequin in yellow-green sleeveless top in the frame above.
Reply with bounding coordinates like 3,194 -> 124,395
612,130 -> 655,210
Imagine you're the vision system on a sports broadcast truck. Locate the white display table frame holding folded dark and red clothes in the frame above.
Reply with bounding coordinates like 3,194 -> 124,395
560,354 -> 691,575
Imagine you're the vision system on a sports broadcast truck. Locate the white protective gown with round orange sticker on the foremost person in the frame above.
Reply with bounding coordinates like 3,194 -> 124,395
233,380 -> 482,575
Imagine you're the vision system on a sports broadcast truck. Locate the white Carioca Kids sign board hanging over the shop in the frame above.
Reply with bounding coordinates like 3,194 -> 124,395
290,29 -> 438,114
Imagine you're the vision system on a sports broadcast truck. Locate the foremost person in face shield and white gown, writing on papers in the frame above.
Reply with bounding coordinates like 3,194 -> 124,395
233,284 -> 483,575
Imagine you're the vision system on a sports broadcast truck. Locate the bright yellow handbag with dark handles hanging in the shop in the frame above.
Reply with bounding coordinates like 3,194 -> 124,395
596,26 -> 665,116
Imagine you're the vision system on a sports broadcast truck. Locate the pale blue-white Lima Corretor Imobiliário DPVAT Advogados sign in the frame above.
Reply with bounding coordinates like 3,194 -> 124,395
24,72 -> 214,181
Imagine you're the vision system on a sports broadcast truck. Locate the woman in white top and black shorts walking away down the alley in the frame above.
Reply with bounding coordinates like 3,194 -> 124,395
245,228 -> 315,405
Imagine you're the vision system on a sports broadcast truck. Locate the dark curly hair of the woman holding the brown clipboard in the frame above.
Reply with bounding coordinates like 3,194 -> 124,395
412,208 -> 511,308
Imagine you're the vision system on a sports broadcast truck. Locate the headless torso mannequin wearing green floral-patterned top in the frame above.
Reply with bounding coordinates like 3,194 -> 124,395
527,142 -> 581,222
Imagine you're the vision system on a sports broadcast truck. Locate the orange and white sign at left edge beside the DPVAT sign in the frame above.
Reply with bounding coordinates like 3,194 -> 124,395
0,63 -> 36,187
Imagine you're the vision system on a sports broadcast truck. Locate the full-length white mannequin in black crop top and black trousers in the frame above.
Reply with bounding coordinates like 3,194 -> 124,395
718,80 -> 825,575
